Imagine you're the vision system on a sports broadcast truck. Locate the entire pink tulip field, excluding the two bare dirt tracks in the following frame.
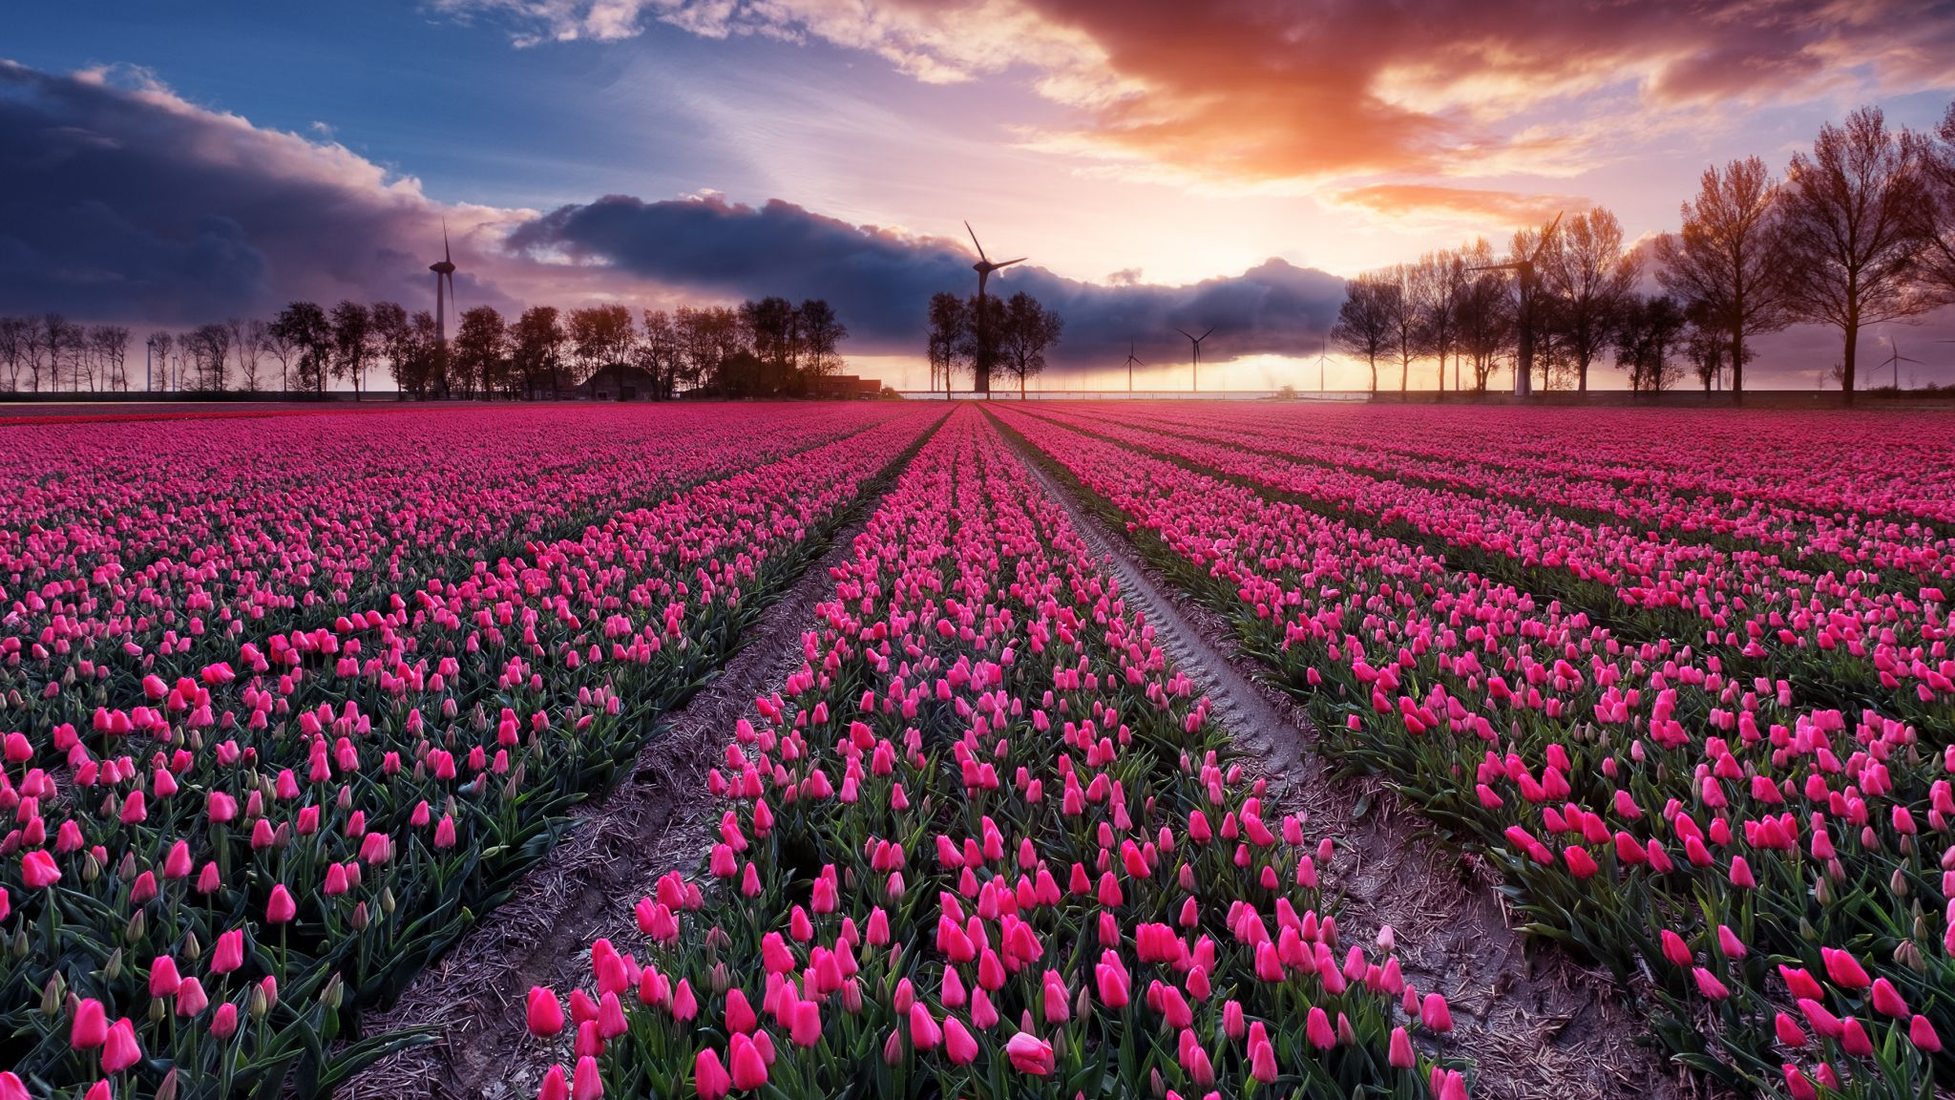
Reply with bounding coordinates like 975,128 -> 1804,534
0,401 -> 1955,1100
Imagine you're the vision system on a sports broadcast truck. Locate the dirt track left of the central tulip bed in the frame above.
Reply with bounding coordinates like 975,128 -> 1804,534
340,519 -> 874,1100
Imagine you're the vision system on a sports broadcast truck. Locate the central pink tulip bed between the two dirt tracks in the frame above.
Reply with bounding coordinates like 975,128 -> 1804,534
528,408 -> 1466,1100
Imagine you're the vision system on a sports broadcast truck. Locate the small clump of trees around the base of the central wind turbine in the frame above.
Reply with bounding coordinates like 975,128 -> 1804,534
925,291 -> 1065,401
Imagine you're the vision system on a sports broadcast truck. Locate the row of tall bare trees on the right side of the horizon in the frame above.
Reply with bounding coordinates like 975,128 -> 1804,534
1331,104 -> 1955,401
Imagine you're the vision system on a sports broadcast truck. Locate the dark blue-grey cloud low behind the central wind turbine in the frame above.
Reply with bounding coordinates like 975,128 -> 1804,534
510,195 -> 1343,361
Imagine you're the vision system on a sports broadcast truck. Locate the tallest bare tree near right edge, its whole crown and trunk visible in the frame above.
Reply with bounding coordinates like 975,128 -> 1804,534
1783,107 -> 1935,404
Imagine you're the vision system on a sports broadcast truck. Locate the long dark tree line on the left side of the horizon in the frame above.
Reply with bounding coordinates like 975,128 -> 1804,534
0,297 -> 848,401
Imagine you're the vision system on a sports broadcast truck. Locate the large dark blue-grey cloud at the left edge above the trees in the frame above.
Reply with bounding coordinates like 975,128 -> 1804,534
0,61 -> 528,324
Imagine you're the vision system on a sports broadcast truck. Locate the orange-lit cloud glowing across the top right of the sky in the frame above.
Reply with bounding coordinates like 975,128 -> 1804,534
434,0 -> 1955,182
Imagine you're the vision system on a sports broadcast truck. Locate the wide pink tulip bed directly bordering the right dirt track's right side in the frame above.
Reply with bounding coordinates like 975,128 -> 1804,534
999,410 -> 1955,1096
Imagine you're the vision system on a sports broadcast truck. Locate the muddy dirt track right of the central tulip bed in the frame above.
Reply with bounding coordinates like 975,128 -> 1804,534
1019,435 -> 1697,1100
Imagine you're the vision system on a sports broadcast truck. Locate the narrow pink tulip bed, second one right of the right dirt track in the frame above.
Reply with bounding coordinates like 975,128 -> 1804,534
1032,404 -> 1955,727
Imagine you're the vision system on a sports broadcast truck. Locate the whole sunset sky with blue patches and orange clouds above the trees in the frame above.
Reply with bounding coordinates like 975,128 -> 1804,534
0,0 -> 1955,389
